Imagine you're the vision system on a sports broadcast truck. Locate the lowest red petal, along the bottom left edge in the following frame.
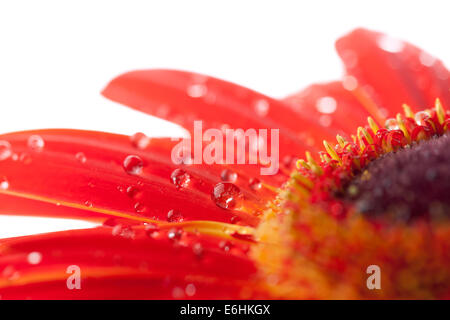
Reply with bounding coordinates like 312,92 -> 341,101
0,227 -> 258,299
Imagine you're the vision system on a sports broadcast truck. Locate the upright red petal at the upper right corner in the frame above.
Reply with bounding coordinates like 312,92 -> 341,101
336,29 -> 450,117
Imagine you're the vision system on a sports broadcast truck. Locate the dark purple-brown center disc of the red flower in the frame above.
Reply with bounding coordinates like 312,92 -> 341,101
344,135 -> 450,221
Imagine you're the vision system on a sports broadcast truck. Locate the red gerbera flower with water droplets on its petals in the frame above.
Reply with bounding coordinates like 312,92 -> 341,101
0,29 -> 450,299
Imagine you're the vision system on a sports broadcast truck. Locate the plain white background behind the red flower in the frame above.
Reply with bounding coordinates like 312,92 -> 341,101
0,0 -> 450,237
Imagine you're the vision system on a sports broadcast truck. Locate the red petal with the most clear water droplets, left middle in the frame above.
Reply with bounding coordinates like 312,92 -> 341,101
0,130 -> 265,225
